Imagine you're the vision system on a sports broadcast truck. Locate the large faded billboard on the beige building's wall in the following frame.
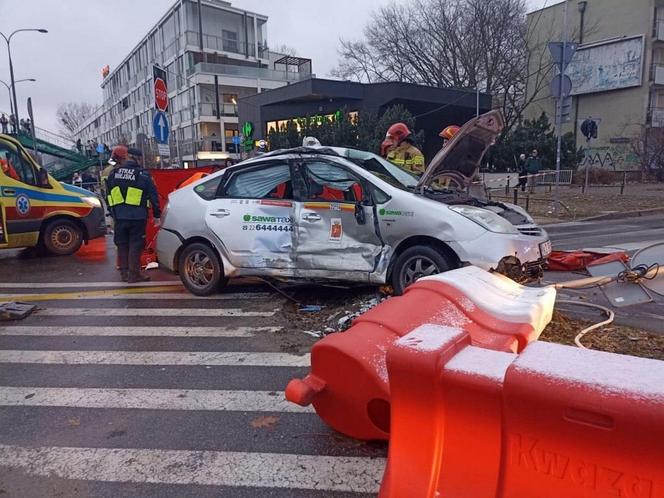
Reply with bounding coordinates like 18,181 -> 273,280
567,36 -> 643,95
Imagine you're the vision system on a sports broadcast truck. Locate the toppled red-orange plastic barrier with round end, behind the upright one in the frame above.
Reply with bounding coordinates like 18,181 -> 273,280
286,267 -> 555,440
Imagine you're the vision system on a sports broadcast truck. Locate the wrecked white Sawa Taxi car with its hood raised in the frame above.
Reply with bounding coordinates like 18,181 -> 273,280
157,111 -> 551,295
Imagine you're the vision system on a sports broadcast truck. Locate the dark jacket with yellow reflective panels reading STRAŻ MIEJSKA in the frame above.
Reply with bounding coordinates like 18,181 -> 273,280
106,161 -> 161,220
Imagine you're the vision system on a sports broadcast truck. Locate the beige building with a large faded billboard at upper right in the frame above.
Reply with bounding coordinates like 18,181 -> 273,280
524,0 -> 664,171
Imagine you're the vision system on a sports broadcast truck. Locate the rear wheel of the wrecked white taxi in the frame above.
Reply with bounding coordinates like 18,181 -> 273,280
178,242 -> 228,296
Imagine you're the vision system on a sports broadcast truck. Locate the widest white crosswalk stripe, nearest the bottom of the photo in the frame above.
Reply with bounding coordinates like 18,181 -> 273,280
0,445 -> 385,496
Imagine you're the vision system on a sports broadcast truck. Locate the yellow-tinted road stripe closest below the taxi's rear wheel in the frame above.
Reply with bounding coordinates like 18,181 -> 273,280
0,289 -> 270,301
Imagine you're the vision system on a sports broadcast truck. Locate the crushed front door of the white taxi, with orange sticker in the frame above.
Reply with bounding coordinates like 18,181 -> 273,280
295,160 -> 382,272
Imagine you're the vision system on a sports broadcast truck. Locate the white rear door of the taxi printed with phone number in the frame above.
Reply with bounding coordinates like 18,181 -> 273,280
205,162 -> 294,269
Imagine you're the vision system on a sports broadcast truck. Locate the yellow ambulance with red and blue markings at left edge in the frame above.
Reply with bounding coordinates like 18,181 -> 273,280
0,134 -> 106,256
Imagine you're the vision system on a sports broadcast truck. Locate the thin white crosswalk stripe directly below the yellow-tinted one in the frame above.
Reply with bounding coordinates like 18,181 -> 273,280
35,308 -> 276,317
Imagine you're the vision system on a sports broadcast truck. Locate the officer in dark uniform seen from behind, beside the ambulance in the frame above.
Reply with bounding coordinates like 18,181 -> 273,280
106,148 -> 161,283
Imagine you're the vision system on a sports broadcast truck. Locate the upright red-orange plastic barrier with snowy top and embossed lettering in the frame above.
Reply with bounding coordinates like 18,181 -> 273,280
380,326 -> 664,498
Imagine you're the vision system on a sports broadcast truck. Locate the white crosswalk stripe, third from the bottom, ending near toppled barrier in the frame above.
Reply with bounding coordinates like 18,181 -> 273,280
0,350 -> 309,367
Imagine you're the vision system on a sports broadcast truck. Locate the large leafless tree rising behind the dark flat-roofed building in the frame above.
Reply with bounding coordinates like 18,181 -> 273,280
332,0 -> 551,131
